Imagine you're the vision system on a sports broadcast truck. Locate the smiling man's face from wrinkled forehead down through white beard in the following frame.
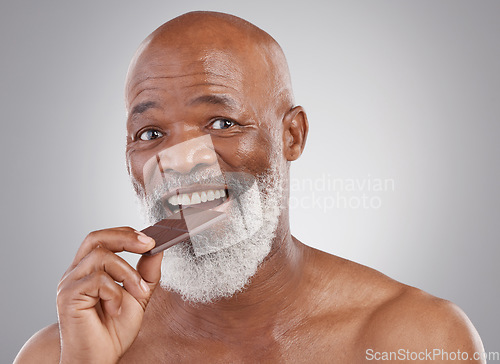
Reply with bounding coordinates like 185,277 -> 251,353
127,39 -> 290,302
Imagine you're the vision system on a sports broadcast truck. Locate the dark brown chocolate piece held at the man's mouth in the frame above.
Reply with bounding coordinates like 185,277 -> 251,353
142,207 -> 225,255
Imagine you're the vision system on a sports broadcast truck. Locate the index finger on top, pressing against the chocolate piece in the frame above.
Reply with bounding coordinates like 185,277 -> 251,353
70,227 -> 155,269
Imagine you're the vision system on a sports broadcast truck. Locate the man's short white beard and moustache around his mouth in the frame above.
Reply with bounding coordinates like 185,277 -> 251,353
133,159 -> 284,303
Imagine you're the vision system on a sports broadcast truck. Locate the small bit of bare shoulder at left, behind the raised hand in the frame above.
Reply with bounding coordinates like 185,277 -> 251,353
14,324 -> 61,364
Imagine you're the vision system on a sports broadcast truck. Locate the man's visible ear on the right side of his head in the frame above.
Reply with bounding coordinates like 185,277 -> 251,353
283,106 -> 309,161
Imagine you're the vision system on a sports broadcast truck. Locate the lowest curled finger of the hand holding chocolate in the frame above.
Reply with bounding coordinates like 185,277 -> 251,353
57,271 -> 124,316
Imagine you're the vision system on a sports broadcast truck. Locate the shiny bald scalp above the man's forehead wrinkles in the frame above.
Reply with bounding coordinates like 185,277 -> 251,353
126,12 -> 294,113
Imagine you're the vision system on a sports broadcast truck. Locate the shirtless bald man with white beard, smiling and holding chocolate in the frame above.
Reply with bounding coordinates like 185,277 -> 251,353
16,12 -> 483,363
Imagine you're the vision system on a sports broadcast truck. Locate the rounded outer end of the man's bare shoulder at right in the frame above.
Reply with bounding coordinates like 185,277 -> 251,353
362,287 -> 484,363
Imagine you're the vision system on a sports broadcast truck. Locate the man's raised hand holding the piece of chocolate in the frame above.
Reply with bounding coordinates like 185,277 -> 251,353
57,227 -> 162,363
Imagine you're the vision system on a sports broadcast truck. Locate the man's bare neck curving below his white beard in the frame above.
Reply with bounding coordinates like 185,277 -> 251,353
150,224 -> 305,341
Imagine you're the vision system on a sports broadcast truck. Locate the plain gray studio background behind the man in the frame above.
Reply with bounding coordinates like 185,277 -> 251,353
0,0 -> 500,362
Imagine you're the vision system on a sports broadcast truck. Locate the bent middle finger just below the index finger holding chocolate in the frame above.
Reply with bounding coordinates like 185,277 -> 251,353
63,246 -> 150,301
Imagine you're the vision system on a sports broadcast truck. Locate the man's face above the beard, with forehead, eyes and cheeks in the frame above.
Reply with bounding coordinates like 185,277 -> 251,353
127,46 -> 279,191
